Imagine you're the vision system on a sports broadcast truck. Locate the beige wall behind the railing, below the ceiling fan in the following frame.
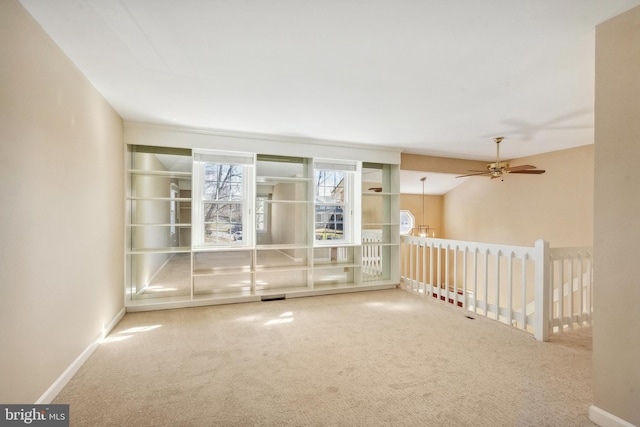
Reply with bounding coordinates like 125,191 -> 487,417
444,145 -> 594,247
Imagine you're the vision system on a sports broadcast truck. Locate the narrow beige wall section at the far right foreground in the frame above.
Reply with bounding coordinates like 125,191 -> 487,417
593,7 -> 640,426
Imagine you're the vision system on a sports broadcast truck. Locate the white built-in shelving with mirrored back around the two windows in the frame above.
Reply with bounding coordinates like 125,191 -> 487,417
125,145 -> 400,310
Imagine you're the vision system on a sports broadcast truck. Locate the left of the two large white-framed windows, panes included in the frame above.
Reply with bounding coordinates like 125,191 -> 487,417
193,152 -> 253,246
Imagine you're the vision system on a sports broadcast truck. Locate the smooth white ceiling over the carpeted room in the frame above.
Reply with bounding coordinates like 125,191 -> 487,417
21,0 -> 640,187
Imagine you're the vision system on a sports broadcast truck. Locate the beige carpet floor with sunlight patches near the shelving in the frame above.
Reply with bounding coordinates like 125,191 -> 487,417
54,289 -> 594,426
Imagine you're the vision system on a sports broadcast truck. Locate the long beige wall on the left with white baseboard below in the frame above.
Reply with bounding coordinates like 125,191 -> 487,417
0,0 -> 124,403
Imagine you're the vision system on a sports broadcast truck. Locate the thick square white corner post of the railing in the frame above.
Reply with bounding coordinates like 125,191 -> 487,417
533,240 -> 551,341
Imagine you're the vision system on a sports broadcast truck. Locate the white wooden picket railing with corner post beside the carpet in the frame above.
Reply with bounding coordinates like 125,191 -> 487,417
401,236 -> 593,341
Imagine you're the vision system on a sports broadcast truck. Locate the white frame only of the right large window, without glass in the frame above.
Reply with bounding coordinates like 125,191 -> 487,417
313,159 -> 362,247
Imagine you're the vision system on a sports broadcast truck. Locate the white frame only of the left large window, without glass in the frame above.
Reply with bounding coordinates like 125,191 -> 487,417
191,150 -> 255,249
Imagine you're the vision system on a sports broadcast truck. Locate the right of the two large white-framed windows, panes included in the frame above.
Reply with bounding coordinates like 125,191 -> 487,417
314,161 -> 359,245
